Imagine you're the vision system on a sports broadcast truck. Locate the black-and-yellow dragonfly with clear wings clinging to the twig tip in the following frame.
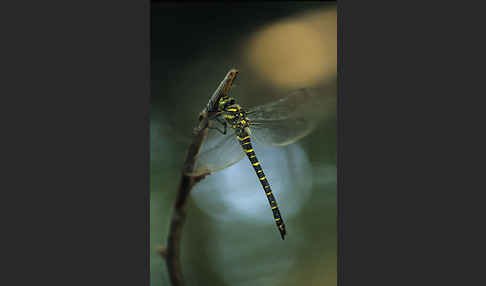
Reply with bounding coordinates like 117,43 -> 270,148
195,69 -> 322,240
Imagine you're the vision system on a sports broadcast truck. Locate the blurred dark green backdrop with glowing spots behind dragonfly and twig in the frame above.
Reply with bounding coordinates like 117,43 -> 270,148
150,2 -> 337,286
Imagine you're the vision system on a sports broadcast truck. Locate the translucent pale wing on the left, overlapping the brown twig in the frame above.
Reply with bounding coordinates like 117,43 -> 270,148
188,128 -> 245,173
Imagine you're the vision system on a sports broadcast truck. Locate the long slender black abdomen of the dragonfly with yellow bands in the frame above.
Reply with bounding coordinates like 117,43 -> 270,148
238,132 -> 287,239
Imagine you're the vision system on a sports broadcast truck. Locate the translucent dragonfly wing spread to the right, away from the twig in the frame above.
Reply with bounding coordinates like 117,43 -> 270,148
247,89 -> 322,146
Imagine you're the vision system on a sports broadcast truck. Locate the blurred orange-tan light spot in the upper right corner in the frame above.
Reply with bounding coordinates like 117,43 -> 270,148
246,10 -> 337,87
